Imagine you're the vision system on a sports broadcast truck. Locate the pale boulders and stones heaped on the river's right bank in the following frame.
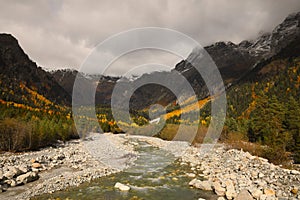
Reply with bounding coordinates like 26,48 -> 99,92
182,146 -> 300,200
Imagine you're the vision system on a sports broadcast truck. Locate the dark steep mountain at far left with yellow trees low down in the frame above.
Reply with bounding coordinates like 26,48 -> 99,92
0,34 -> 71,107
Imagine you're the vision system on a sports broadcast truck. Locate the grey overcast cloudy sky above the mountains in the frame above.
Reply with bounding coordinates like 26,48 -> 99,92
0,0 -> 300,74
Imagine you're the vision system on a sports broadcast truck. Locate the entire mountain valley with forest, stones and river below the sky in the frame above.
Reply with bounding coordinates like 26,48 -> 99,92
0,8 -> 300,200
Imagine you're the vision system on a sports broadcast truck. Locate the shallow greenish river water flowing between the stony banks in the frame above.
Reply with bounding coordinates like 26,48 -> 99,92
36,141 -> 217,200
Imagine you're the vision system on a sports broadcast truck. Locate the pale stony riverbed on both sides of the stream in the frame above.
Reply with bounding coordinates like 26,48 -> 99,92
0,134 -> 300,200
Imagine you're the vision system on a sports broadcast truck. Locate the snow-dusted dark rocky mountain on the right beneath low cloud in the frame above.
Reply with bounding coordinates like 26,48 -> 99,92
175,13 -> 300,96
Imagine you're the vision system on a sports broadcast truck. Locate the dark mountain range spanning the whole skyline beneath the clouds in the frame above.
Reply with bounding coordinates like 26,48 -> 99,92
0,13 -> 300,109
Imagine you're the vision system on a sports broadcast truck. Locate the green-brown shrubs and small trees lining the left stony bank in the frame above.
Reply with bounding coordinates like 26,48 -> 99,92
0,118 -> 78,152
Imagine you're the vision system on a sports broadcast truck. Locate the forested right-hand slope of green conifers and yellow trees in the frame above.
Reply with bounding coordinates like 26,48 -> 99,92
224,27 -> 300,164
